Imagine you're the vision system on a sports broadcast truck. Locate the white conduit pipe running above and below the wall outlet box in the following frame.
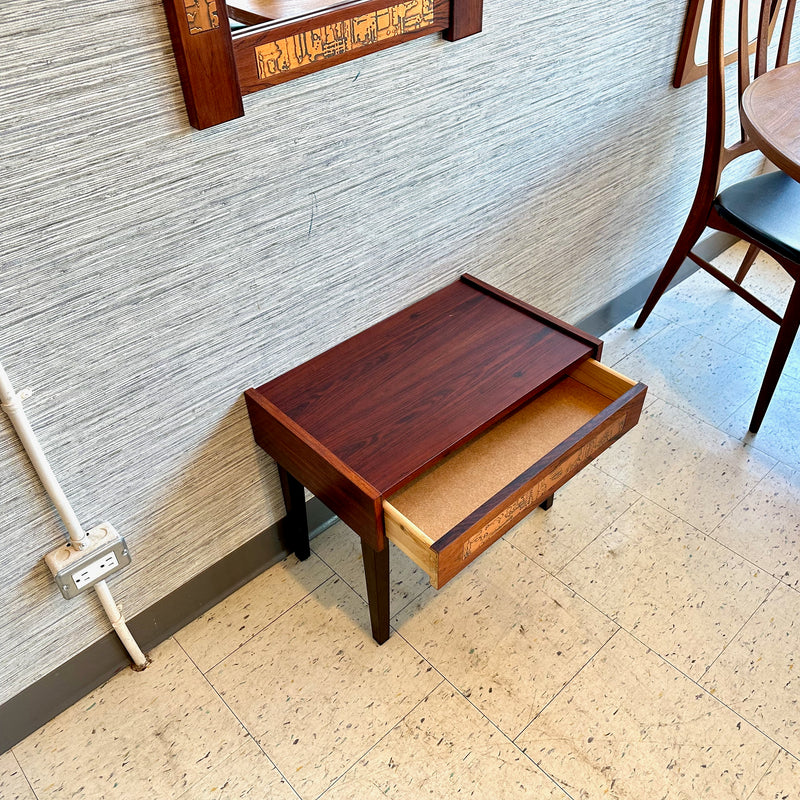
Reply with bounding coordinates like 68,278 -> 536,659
0,363 -> 147,669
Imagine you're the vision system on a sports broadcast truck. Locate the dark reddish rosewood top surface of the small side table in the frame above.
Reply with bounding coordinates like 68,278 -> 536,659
255,277 -> 600,494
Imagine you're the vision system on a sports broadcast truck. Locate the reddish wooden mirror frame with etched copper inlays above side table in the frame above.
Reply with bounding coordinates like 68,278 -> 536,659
162,0 -> 483,129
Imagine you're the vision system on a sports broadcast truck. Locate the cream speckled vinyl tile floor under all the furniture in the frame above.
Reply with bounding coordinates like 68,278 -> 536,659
0,247 -> 800,800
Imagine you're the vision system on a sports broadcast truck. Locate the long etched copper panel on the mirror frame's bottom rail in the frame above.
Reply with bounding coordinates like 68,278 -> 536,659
255,0 -> 434,80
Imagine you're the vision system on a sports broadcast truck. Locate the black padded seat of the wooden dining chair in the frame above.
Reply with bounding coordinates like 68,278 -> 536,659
714,172 -> 800,262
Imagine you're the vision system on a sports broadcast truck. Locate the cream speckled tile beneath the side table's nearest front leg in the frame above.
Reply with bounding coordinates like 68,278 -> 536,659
207,578 -> 442,799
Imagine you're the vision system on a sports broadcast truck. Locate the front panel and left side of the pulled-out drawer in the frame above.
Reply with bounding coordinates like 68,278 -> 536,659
384,376 -> 647,588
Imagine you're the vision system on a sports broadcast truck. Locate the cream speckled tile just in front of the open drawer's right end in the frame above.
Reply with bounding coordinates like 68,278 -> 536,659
595,400 -> 776,533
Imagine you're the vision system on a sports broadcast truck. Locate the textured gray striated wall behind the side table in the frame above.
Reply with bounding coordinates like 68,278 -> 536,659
0,0 -> 768,702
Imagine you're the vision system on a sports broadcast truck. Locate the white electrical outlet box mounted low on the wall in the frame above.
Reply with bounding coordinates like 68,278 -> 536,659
44,522 -> 131,598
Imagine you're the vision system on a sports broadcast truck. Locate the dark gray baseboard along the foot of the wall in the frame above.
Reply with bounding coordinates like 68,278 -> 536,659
0,233 -> 736,754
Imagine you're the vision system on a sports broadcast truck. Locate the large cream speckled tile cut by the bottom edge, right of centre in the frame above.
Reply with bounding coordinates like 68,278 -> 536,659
516,631 -> 778,800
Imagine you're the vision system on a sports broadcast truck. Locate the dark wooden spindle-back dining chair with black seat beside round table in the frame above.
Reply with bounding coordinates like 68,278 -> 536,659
634,0 -> 800,433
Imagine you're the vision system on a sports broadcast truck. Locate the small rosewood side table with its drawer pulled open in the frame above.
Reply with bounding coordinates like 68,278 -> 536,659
245,275 -> 646,642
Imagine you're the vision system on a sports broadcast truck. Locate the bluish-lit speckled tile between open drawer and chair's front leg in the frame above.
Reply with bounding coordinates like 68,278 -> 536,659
614,320 -> 764,425
